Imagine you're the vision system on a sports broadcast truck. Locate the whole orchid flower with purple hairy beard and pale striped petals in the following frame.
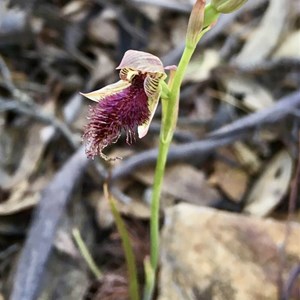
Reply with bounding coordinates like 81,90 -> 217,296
82,50 -> 167,160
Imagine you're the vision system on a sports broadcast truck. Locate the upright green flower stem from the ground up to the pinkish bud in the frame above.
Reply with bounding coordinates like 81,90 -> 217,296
148,45 -> 196,296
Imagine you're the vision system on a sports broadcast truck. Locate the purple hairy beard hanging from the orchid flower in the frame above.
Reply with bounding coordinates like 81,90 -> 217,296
83,75 -> 150,159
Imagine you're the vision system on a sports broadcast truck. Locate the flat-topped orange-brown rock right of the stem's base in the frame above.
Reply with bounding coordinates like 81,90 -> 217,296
158,204 -> 300,300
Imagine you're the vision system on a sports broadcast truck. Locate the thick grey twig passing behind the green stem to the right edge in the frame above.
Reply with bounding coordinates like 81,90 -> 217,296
111,90 -> 300,181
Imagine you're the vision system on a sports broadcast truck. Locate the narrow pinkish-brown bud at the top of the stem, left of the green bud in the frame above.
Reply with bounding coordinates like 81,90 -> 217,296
186,0 -> 205,47
